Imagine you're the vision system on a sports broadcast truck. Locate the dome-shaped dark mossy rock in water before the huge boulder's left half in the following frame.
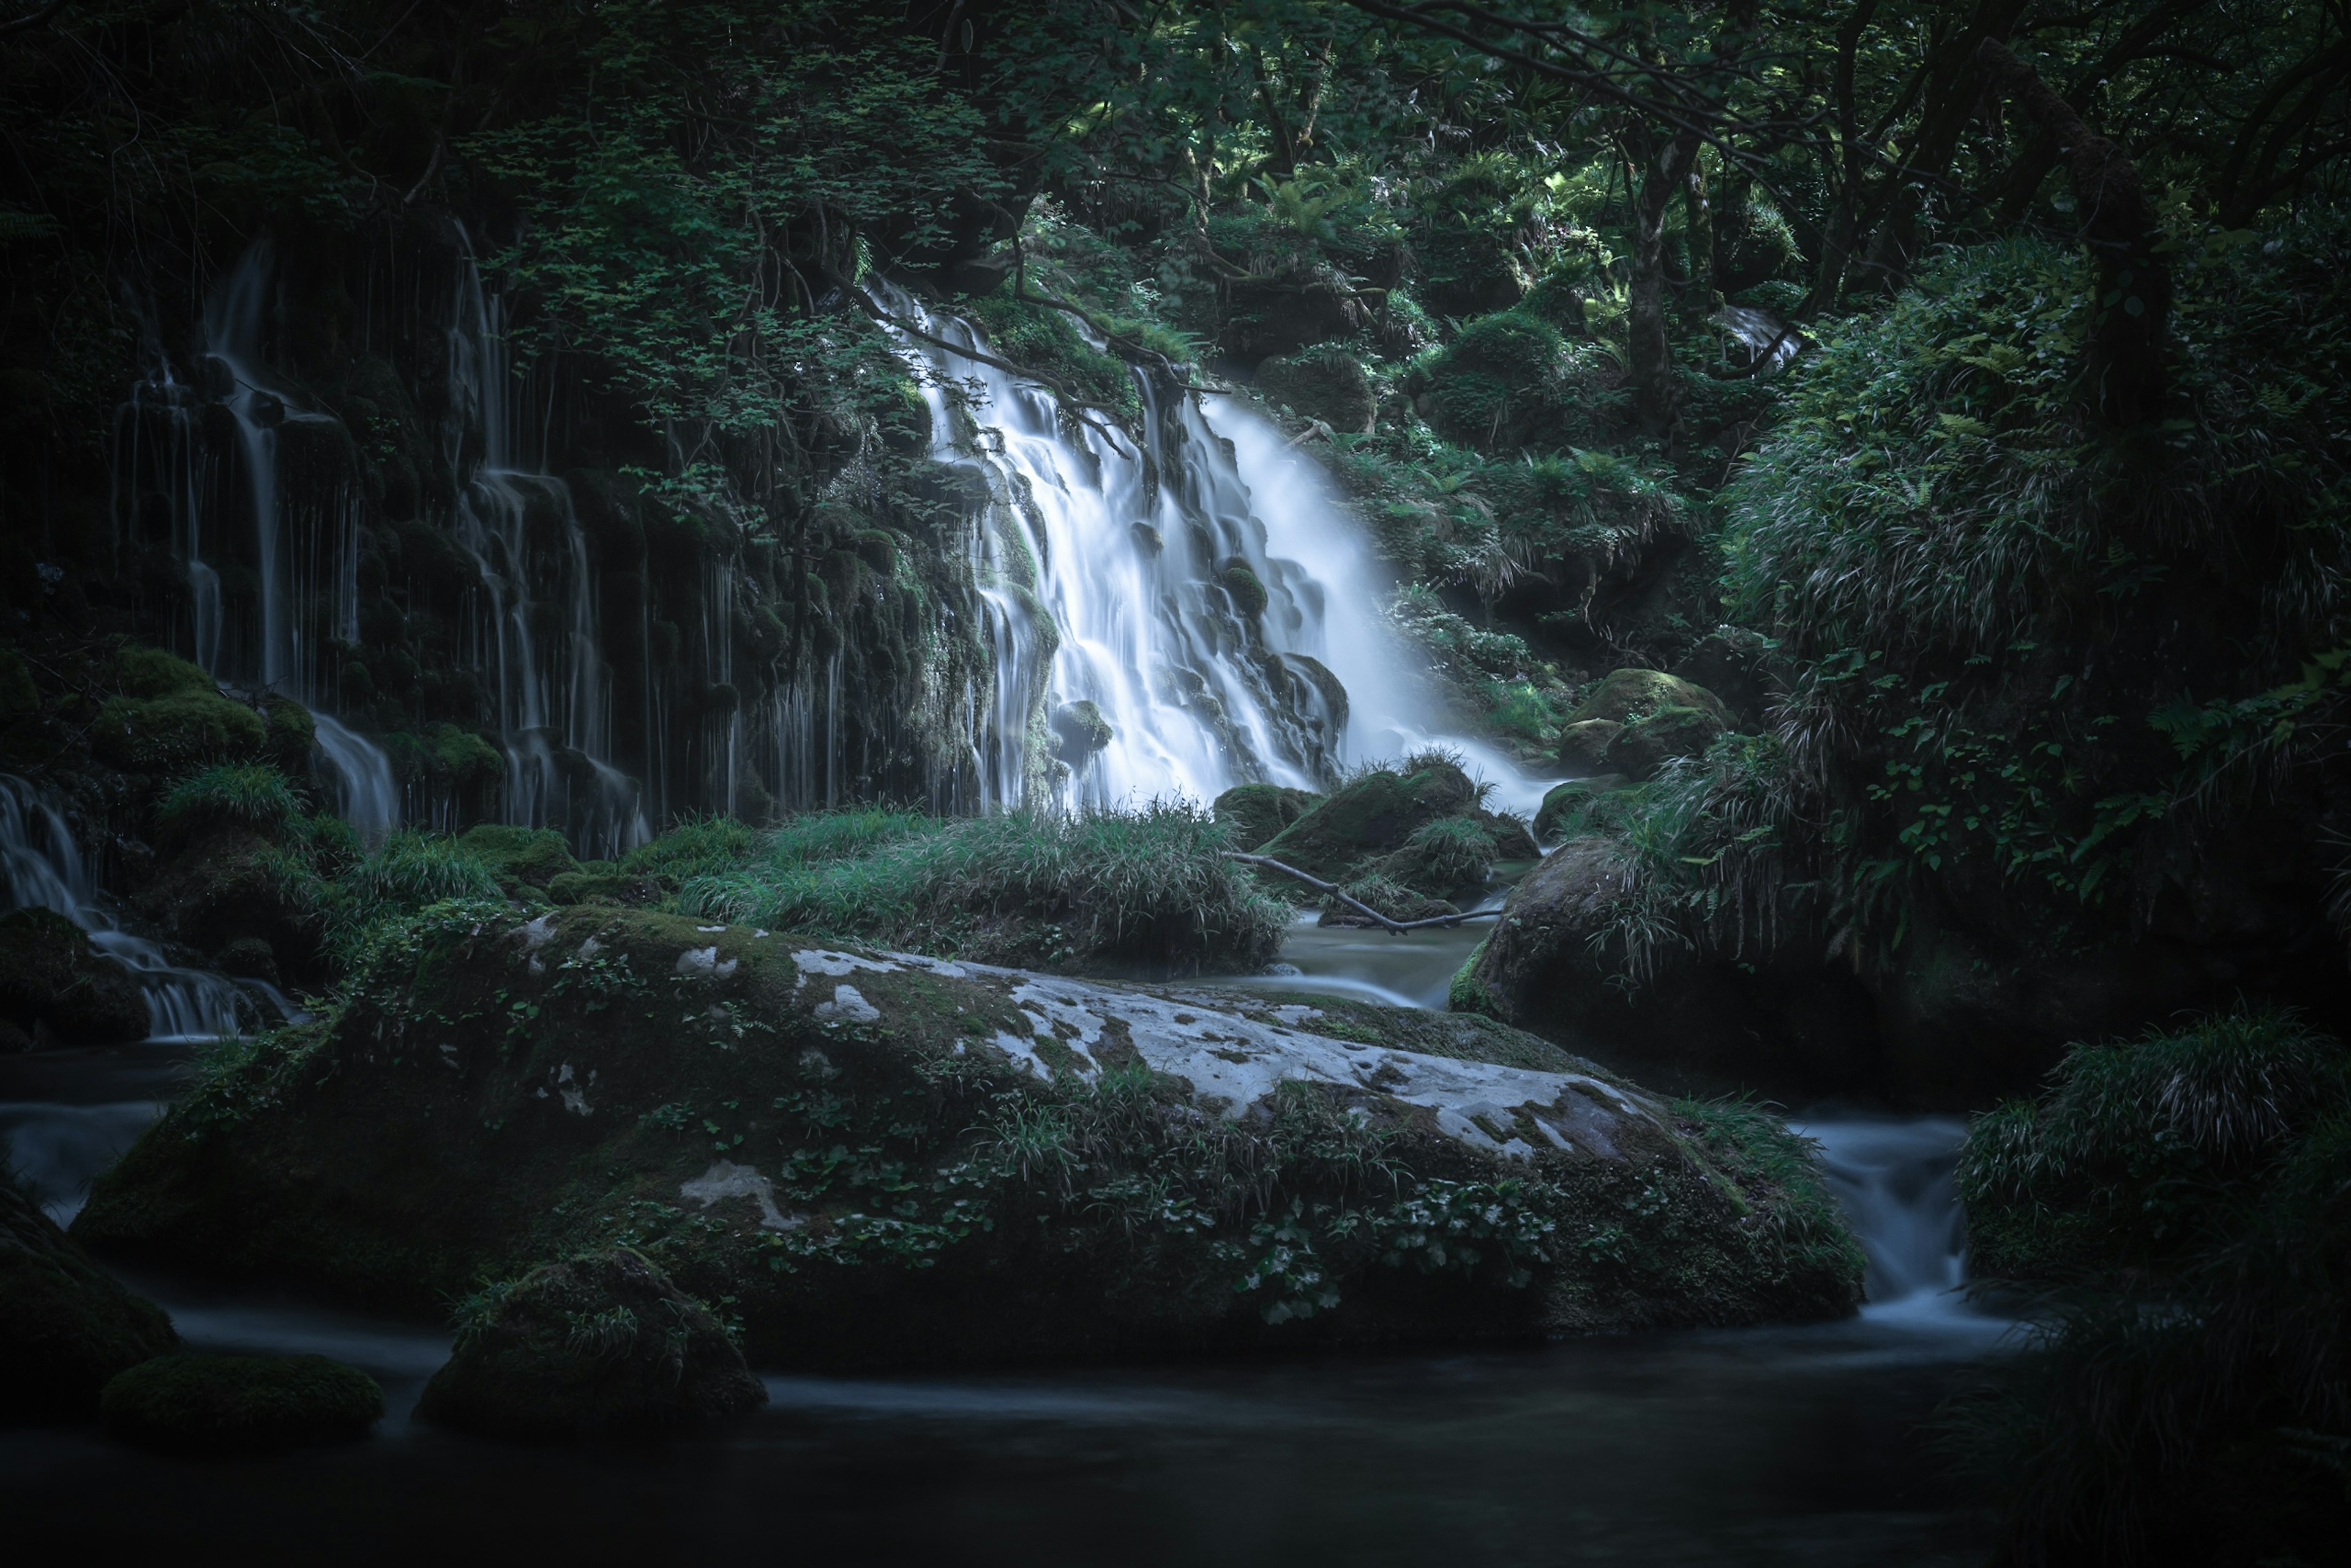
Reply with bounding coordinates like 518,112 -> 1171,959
416,1246 -> 767,1439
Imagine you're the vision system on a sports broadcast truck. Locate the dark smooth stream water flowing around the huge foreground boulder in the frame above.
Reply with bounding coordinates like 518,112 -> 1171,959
0,902 -> 2006,1568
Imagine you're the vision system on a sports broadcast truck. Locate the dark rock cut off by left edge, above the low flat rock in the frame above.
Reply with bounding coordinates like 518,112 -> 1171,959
0,1173 -> 179,1422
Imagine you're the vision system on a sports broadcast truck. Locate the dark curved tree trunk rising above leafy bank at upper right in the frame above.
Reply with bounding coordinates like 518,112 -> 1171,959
1975,37 -> 2172,426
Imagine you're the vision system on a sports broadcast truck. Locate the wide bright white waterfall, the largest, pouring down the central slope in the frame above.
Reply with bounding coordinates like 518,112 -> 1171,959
884,289 -> 1542,809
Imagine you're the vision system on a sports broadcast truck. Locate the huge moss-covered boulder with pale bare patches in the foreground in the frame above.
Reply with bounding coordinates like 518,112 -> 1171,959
75,902 -> 1859,1366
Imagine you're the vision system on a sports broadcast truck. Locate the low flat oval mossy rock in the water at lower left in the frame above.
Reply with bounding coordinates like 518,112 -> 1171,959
99,1354 -> 383,1453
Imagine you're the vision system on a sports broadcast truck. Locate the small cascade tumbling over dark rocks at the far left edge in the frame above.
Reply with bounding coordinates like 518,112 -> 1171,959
0,773 -> 296,1039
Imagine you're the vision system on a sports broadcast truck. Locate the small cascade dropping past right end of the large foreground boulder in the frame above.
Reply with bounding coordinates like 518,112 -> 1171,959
1796,1117 -> 1968,1314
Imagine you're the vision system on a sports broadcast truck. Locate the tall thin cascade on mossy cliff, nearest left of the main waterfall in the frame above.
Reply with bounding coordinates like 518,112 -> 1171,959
442,236 -> 648,856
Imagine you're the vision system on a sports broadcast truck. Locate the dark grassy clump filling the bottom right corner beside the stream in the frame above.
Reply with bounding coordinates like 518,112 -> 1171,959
1947,1006 -> 2351,1563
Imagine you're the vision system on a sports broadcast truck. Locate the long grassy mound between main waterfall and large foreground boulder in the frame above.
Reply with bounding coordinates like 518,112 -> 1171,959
680,804 -> 1284,973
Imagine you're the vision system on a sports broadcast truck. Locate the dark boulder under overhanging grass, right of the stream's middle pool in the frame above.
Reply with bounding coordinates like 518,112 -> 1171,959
1453,835 -> 1881,1098
